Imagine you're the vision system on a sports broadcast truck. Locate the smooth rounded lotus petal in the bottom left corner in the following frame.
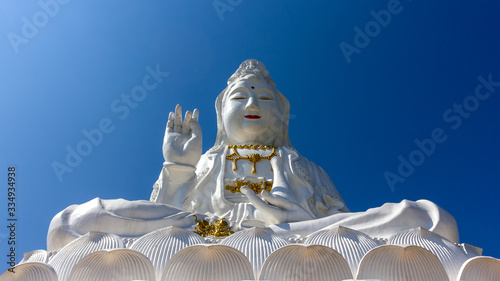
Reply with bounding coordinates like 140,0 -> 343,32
0,262 -> 57,281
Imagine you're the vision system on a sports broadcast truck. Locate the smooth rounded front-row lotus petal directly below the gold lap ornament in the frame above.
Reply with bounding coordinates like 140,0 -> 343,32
161,245 -> 254,281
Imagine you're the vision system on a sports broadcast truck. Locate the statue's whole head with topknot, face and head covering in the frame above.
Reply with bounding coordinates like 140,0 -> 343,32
214,59 -> 291,148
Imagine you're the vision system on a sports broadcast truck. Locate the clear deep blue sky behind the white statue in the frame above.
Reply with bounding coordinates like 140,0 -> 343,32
0,0 -> 500,268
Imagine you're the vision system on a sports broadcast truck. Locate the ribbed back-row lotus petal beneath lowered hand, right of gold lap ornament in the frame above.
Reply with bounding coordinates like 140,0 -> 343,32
221,227 -> 289,276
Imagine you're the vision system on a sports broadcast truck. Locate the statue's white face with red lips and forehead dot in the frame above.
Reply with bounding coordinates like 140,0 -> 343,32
222,79 -> 285,145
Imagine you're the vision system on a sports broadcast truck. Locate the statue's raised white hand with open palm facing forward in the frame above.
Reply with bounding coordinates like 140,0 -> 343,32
163,104 -> 202,166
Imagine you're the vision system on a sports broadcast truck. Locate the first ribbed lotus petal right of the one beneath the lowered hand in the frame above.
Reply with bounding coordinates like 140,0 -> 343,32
304,226 -> 379,276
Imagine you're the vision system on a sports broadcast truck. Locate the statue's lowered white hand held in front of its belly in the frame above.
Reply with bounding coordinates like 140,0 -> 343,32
240,186 -> 313,225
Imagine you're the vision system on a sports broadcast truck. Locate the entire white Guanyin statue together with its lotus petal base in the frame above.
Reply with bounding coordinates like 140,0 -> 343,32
5,59 -> 500,280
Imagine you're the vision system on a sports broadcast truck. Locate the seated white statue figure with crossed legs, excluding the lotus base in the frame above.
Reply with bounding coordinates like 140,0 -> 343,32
47,60 -> 458,250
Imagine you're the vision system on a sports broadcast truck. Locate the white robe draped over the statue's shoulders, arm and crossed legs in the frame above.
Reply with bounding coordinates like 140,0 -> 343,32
47,147 -> 459,250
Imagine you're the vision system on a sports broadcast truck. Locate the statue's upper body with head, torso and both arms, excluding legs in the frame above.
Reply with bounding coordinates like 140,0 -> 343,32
151,60 -> 349,225
